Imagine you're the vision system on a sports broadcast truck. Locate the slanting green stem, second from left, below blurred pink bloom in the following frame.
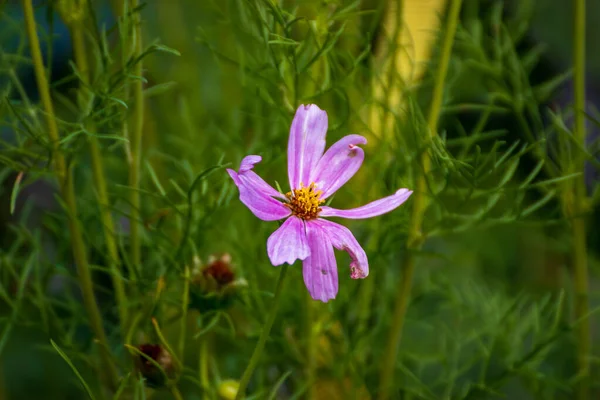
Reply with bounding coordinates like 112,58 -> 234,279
71,15 -> 128,335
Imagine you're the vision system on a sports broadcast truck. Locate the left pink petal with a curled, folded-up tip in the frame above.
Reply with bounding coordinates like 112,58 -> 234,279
227,156 -> 291,221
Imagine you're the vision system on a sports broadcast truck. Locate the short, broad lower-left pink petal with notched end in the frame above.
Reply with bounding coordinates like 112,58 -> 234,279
267,217 -> 310,265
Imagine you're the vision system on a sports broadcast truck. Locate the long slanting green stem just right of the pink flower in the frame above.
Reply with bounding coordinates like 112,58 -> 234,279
378,0 -> 462,400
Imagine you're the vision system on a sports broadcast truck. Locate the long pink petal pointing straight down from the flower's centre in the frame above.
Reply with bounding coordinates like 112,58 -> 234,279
302,221 -> 338,303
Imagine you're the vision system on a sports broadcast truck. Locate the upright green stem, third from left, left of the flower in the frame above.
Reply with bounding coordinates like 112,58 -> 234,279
129,0 -> 144,268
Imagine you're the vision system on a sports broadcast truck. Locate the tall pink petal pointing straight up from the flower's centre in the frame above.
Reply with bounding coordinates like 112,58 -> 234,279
288,104 -> 327,189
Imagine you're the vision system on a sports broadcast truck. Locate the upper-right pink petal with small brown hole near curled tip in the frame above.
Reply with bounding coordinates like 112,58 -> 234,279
310,135 -> 367,199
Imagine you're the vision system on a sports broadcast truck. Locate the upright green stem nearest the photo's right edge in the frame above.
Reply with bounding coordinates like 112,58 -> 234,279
572,0 -> 591,400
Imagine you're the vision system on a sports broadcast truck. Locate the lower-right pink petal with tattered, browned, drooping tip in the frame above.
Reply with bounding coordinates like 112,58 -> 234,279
312,219 -> 369,279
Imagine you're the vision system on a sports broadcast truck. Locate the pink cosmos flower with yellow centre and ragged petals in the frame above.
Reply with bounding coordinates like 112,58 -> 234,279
227,104 -> 412,302
